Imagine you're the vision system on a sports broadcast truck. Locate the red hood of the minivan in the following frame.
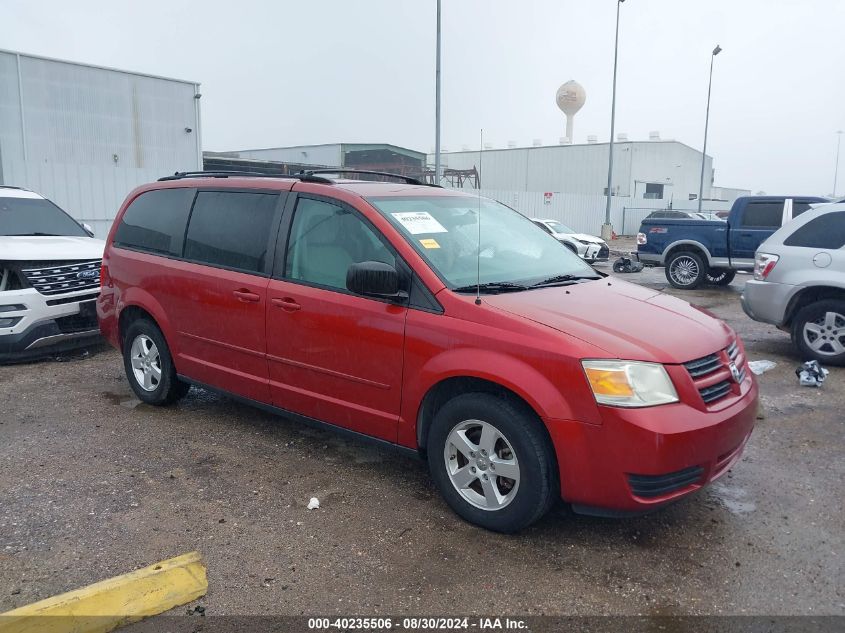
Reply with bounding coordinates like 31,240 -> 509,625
485,279 -> 733,364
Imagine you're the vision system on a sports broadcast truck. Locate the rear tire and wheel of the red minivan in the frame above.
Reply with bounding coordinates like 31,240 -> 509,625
123,318 -> 191,406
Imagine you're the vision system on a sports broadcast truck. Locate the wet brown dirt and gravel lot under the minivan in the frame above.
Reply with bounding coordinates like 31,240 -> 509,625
0,262 -> 845,615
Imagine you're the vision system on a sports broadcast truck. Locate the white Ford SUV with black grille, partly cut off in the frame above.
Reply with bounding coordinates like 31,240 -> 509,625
0,185 -> 105,362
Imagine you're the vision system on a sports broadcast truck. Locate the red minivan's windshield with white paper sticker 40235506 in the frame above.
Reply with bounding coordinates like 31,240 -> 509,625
368,196 -> 600,292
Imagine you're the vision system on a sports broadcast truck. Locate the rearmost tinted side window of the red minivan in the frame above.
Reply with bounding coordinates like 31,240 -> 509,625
114,188 -> 194,257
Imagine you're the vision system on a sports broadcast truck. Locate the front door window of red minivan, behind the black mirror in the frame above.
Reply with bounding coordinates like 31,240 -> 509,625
285,198 -> 396,290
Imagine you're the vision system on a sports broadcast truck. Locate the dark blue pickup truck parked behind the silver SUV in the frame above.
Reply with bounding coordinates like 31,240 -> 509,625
637,196 -> 828,290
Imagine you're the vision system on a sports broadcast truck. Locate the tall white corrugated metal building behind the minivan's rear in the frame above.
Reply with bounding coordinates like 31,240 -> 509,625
0,50 -> 202,237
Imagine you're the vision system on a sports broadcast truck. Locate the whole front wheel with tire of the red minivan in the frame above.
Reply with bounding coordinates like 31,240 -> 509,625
427,393 -> 559,533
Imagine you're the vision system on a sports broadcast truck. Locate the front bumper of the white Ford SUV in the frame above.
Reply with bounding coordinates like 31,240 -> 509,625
0,289 -> 100,362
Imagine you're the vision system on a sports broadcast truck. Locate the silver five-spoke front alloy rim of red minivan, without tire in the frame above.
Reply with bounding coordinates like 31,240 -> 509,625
443,420 -> 520,510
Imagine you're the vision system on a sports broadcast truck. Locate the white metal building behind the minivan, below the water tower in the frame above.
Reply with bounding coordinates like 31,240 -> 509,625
428,140 -> 744,206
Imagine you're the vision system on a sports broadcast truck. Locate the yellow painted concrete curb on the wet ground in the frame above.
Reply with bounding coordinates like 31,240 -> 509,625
0,552 -> 208,633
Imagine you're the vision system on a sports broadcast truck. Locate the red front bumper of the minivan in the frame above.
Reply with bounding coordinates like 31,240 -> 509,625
545,371 -> 758,515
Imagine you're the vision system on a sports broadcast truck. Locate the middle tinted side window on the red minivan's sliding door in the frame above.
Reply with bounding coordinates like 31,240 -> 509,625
185,191 -> 279,273
